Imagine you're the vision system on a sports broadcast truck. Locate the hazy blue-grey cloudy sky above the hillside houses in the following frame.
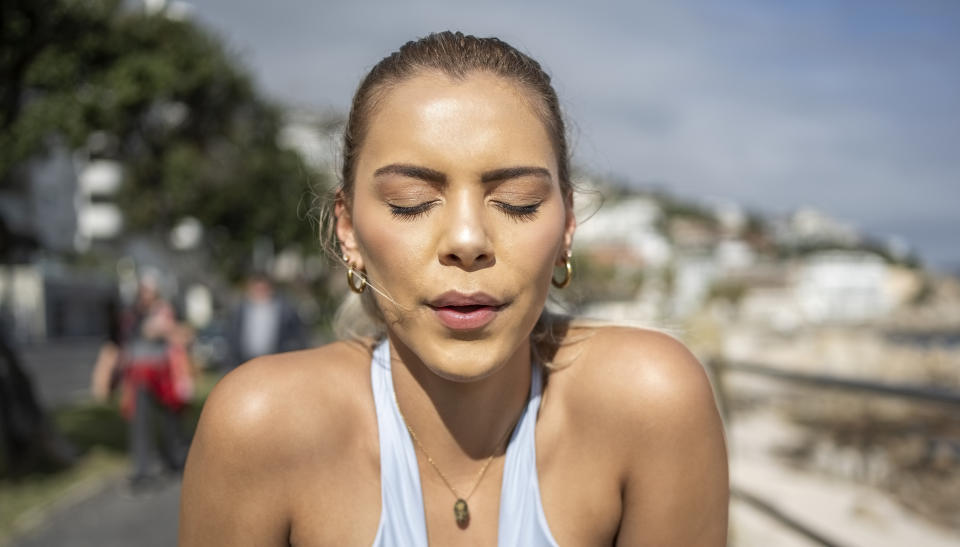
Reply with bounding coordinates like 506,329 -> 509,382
184,0 -> 960,269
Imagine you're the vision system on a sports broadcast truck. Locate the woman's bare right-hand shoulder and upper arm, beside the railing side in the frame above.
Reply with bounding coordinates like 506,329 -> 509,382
550,327 -> 729,546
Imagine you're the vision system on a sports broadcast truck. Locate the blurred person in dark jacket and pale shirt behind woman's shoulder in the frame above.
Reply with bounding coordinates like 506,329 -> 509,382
227,273 -> 307,369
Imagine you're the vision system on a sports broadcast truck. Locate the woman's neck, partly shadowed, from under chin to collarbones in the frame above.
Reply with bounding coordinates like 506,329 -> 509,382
390,338 -> 530,462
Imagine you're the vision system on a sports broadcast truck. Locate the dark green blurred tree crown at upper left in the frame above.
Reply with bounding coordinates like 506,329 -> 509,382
0,0 -> 323,278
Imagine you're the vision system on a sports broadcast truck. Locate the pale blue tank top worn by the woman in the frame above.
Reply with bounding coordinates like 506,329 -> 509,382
370,340 -> 557,547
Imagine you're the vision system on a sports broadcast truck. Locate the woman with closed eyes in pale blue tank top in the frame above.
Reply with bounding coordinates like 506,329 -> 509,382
180,32 -> 728,547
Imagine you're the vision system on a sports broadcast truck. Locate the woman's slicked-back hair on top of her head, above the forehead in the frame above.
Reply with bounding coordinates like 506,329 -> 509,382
340,31 -> 572,199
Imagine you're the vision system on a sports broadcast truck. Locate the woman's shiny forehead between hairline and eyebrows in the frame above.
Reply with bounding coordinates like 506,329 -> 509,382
358,72 -> 556,173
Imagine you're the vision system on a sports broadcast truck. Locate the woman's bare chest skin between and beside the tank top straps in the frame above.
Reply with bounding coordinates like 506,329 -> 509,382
288,404 -> 620,546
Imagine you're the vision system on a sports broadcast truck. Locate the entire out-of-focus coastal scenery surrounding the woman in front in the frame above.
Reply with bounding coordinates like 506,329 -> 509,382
0,0 -> 960,546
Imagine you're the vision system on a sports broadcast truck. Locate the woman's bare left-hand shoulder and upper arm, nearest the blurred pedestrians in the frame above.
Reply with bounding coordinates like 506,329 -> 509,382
180,343 -> 376,546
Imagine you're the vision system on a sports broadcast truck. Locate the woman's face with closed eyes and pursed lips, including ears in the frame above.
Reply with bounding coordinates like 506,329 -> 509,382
337,69 -> 575,381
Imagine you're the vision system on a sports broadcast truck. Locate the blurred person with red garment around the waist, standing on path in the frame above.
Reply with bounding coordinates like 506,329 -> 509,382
93,273 -> 193,490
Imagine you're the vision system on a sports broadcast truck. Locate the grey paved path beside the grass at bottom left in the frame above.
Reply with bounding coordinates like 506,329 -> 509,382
11,479 -> 180,547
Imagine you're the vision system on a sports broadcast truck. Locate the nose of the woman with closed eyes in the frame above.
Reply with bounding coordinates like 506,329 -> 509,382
438,195 -> 494,271
